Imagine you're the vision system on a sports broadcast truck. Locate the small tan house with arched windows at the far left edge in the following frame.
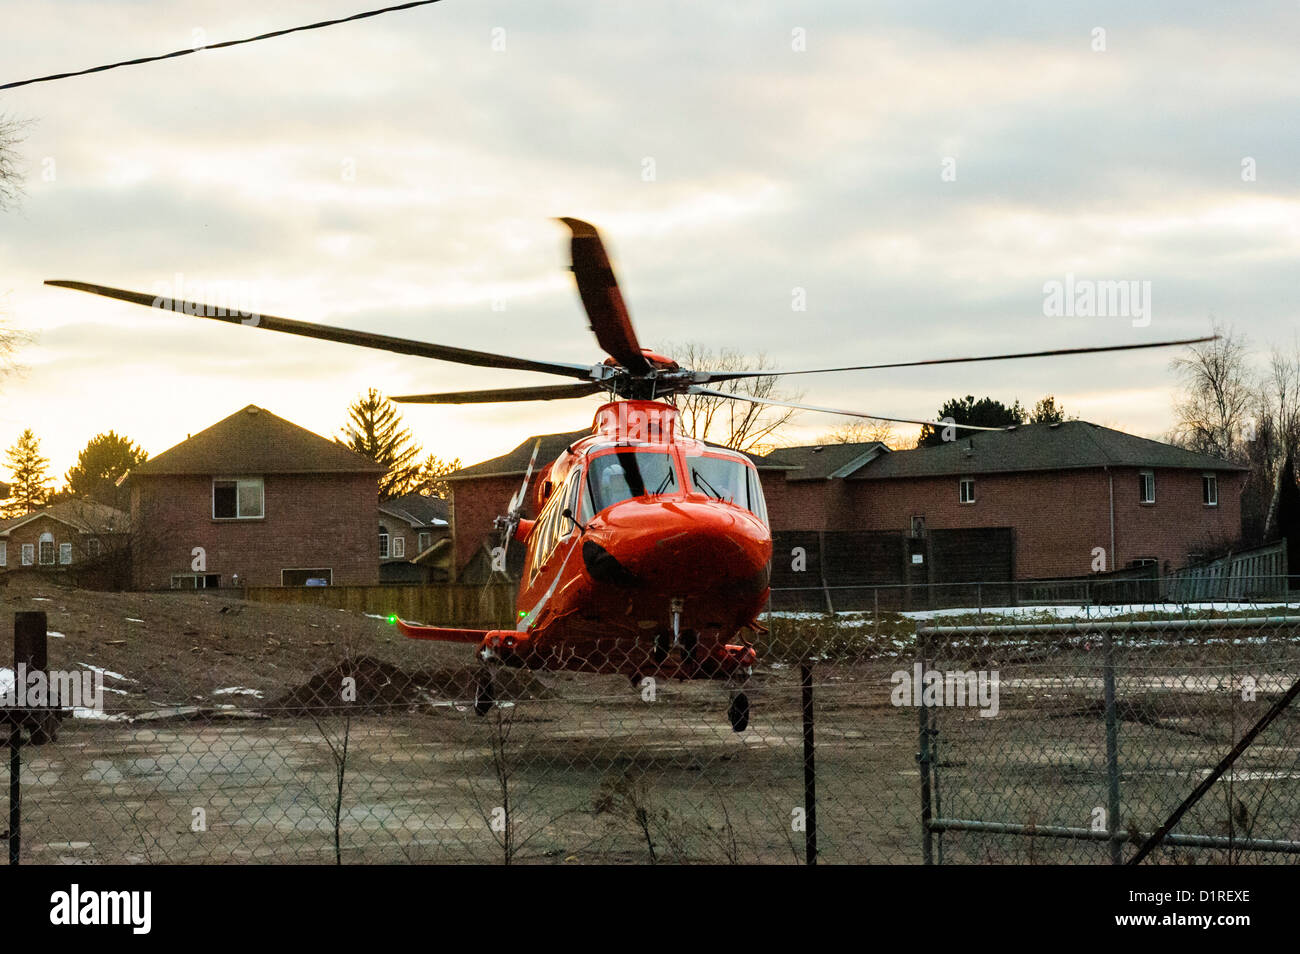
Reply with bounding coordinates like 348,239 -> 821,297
0,500 -> 130,572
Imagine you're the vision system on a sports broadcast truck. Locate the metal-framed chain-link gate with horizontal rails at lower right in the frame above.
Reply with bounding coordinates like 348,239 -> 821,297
918,606 -> 1300,864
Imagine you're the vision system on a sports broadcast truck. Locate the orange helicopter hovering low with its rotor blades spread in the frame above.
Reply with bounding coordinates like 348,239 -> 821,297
46,218 -> 1212,732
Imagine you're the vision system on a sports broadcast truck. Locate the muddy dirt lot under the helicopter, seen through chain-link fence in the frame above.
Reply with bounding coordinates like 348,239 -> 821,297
0,581 -> 1300,864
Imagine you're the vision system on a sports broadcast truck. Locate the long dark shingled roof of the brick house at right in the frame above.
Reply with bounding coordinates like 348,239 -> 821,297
850,421 -> 1247,481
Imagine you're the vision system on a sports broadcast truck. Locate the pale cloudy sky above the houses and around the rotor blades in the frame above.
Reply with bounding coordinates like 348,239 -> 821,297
0,0 -> 1300,476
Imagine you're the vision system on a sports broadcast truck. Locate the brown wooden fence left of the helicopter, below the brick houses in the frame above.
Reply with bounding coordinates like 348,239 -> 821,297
246,584 -> 515,629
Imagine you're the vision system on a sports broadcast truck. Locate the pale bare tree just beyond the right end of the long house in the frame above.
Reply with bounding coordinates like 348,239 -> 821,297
1173,320 -> 1256,460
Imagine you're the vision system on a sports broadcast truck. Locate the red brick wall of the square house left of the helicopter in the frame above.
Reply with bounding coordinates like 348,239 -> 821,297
131,474 -> 380,589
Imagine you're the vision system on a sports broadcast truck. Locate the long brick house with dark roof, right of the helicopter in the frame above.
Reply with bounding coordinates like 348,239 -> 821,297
764,421 -> 1247,580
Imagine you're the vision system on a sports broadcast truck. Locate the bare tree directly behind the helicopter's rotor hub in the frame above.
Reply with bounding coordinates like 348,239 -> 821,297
664,342 -> 803,452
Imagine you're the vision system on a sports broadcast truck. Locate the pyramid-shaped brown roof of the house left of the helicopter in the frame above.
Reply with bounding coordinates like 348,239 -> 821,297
131,404 -> 384,477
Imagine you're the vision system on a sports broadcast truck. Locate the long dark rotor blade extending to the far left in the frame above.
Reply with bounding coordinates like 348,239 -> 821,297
46,281 -> 592,378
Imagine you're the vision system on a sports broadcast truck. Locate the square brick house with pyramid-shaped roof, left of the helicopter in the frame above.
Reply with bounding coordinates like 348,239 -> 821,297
126,404 -> 384,589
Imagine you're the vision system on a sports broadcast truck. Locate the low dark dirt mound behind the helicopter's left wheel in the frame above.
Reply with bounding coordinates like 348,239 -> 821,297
271,656 -> 549,715
